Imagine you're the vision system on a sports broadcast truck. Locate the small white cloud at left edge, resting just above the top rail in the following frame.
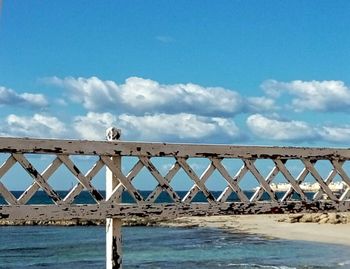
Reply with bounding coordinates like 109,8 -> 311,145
0,114 -> 67,138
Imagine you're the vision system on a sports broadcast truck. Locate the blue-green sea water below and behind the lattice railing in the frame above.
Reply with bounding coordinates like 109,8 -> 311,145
0,189 -> 350,269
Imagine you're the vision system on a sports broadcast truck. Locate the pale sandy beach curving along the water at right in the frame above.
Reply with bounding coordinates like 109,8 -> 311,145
166,214 -> 350,246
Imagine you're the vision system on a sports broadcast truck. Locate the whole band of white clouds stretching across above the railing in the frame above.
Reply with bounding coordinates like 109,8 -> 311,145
0,77 -> 350,144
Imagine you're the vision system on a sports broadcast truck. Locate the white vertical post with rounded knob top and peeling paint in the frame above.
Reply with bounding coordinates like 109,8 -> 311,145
106,127 -> 123,269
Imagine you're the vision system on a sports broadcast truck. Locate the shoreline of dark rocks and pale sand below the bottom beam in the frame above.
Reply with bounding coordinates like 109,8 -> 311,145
0,212 -> 350,246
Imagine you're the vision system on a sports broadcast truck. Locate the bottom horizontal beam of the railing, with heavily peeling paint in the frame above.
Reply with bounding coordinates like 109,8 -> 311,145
0,200 -> 350,221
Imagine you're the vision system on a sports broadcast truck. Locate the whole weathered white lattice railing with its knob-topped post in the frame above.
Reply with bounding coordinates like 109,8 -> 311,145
0,128 -> 350,268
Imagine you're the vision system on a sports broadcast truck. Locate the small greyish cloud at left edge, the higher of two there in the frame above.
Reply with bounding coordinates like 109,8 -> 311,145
0,86 -> 49,107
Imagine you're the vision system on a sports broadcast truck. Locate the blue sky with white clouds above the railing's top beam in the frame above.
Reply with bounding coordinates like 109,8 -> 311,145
0,0 -> 350,191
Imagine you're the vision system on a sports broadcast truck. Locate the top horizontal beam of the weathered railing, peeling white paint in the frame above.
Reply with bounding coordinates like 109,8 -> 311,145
0,137 -> 350,160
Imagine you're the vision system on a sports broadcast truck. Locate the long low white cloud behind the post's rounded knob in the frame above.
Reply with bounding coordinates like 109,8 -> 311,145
74,112 -> 241,143
